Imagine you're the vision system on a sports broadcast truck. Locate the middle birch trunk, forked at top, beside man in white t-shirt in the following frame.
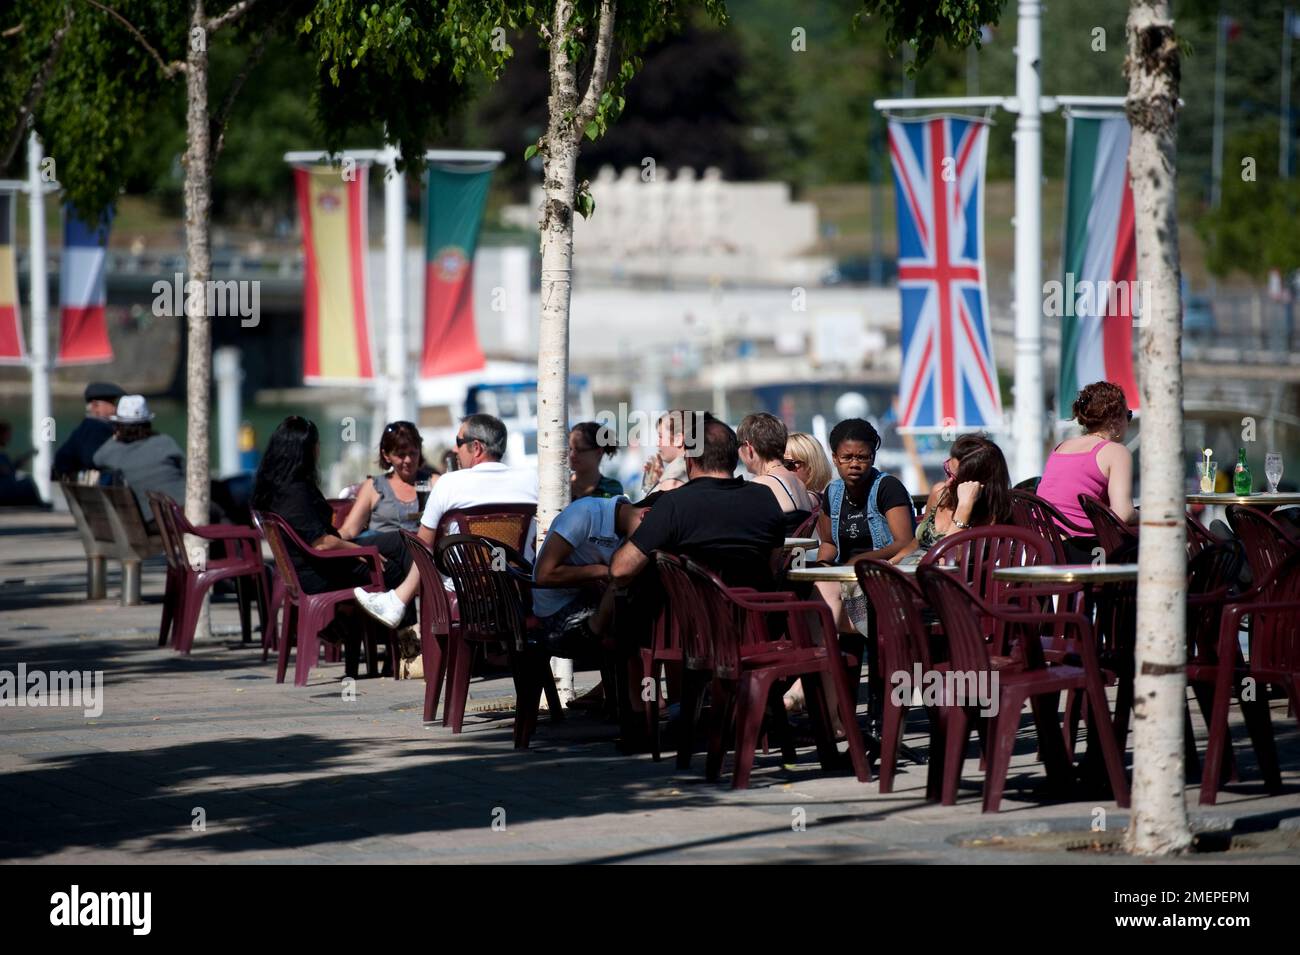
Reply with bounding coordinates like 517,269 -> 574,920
537,0 -> 615,703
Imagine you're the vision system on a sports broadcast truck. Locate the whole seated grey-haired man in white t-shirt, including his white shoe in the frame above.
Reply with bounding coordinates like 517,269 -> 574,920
352,414 -> 537,626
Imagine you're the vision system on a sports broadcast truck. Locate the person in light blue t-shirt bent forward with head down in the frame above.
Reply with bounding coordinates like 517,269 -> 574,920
533,496 -> 653,656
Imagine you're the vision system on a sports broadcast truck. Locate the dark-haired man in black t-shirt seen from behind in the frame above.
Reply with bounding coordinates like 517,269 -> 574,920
610,414 -> 785,590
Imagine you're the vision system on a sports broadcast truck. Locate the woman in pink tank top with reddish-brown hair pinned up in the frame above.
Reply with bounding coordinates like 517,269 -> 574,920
1037,381 -> 1138,563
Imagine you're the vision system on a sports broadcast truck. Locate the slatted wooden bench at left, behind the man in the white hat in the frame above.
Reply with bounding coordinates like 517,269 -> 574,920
62,482 -> 164,607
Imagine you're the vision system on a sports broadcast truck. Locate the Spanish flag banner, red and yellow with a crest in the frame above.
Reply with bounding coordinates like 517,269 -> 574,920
294,162 -> 374,385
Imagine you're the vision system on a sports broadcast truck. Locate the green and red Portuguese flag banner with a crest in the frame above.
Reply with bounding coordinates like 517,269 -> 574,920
420,165 -> 494,378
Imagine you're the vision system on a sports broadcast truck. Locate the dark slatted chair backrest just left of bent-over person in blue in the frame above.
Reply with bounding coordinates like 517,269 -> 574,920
436,534 -> 524,651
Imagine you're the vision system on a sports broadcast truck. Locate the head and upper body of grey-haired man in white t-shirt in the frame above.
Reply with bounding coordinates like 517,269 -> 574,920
420,414 -> 537,547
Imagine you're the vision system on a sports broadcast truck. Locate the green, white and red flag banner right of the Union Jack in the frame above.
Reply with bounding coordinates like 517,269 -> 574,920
1045,113 -> 1141,420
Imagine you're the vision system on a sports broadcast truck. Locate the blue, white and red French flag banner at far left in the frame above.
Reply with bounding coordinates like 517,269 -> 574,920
57,203 -> 113,365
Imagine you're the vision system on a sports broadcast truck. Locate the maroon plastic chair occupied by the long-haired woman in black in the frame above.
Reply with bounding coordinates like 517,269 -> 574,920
252,511 -> 398,686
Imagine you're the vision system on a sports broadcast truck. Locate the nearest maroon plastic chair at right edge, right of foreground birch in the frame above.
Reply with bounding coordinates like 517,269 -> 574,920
1188,552 -> 1300,806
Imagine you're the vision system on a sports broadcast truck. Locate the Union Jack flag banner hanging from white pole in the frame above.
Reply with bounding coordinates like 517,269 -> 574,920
889,117 -> 1002,431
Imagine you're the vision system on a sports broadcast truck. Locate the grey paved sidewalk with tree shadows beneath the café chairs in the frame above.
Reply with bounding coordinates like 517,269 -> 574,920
0,511 -> 1300,864
